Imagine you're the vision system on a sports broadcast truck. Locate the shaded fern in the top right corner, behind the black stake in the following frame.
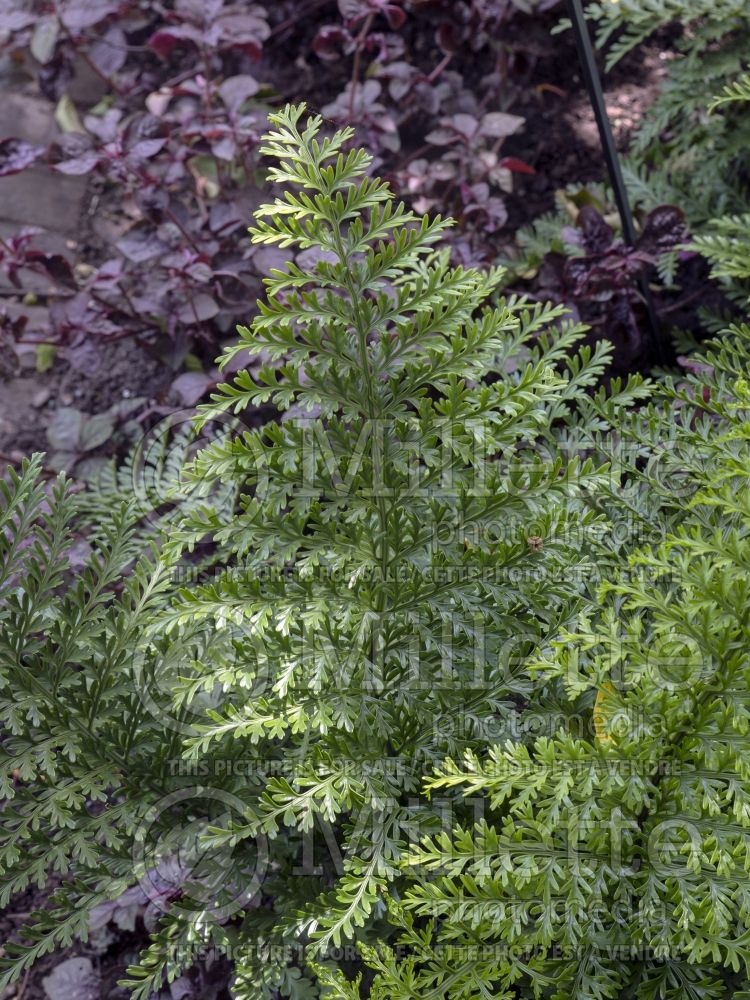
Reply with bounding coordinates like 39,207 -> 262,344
568,0 -> 750,227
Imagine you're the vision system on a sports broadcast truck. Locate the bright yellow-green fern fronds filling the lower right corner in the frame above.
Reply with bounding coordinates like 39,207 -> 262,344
334,326 -> 750,1000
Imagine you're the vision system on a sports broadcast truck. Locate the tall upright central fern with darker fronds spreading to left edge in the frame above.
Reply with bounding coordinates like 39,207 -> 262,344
0,107 -> 647,1000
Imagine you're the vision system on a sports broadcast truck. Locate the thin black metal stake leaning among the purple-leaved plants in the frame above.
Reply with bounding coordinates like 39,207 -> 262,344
568,0 -> 667,365
